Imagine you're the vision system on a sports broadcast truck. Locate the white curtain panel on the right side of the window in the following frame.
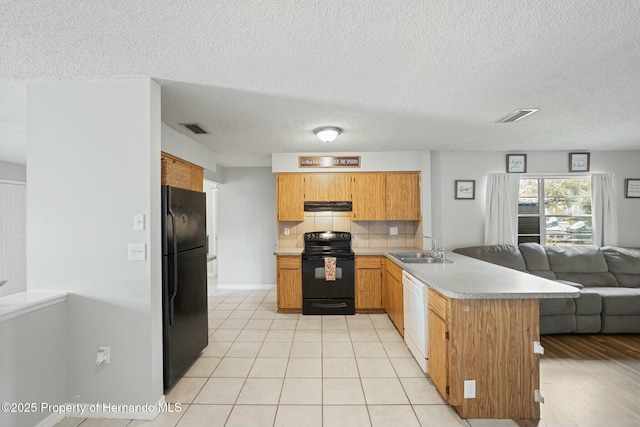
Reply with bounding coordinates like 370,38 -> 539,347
591,174 -> 618,246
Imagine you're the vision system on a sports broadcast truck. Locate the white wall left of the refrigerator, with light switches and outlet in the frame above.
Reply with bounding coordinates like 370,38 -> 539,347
27,78 -> 162,418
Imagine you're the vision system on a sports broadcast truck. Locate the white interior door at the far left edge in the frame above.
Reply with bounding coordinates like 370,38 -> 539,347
0,181 -> 27,296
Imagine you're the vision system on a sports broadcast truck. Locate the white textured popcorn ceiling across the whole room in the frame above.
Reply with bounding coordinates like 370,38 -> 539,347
0,0 -> 640,166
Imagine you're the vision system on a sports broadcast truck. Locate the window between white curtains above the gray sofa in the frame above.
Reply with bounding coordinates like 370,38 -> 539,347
518,177 -> 593,245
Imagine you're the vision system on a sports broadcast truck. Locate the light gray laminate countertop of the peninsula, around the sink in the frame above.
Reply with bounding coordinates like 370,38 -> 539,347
387,252 -> 580,299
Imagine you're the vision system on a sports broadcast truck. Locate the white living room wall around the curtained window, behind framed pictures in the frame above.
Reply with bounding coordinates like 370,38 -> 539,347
431,151 -> 640,249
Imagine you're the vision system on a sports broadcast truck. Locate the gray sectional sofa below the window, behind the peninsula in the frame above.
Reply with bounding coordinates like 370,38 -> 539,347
454,243 -> 640,334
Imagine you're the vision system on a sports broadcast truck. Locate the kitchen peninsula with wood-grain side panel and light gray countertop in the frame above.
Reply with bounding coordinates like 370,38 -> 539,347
276,248 -> 578,419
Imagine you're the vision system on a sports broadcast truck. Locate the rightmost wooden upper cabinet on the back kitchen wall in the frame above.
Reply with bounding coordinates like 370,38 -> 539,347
385,172 -> 421,221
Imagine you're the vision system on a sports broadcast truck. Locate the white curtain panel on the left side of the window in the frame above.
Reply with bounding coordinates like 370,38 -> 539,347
484,173 -> 520,245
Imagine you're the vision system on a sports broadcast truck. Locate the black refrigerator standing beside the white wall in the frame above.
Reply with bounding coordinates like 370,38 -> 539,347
162,185 -> 209,392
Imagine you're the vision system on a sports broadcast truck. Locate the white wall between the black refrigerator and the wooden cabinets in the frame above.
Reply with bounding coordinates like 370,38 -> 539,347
218,168 -> 278,286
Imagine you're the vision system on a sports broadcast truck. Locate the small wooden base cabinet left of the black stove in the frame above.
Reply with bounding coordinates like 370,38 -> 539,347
276,255 -> 302,312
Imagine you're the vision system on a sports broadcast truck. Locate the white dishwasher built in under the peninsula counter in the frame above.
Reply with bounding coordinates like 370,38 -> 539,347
402,270 -> 429,374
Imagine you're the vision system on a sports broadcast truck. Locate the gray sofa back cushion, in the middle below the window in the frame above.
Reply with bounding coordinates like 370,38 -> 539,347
544,246 -> 618,287
